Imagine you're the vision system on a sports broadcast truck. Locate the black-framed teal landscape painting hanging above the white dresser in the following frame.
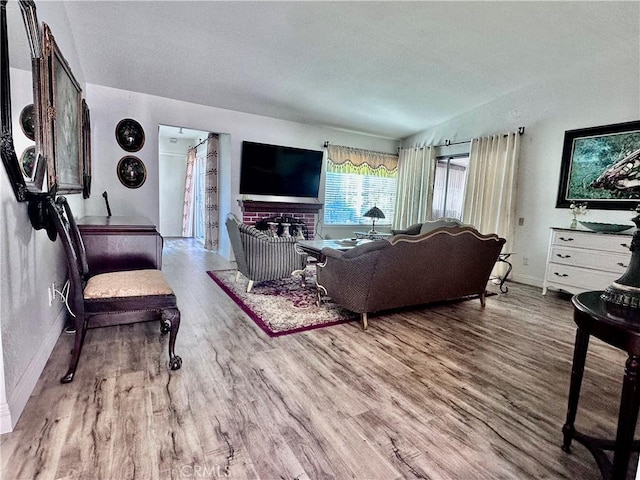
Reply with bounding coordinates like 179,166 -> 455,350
556,121 -> 640,210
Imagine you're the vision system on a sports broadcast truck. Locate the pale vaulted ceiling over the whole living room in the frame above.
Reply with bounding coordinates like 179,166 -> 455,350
8,1 -> 640,138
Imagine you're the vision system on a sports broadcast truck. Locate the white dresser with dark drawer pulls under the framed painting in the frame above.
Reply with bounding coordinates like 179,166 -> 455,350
542,228 -> 633,295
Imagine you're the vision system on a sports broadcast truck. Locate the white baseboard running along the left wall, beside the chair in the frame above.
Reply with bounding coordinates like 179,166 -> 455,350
0,309 -> 67,434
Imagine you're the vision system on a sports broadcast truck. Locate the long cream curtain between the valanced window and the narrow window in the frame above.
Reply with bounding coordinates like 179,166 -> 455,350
392,145 -> 436,230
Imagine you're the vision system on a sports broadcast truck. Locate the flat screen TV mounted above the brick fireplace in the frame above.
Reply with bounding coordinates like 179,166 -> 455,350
240,141 -> 322,198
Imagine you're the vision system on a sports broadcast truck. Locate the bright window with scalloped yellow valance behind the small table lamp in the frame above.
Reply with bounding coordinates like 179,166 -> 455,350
324,145 -> 398,225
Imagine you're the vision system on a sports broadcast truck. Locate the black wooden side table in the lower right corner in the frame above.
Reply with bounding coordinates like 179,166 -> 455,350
562,291 -> 640,480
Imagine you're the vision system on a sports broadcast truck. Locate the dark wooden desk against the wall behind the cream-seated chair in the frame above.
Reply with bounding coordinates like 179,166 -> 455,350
77,216 -> 163,275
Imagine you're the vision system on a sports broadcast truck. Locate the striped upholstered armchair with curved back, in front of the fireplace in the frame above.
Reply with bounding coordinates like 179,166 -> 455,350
225,214 -> 307,292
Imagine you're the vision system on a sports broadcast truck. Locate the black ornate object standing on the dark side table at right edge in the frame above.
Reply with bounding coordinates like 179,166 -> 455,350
601,205 -> 640,309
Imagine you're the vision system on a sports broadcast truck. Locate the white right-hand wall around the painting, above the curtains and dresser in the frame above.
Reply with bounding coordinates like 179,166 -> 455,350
403,44 -> 640,285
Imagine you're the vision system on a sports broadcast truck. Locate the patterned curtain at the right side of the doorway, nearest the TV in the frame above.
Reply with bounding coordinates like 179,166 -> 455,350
204,133 -> 220,250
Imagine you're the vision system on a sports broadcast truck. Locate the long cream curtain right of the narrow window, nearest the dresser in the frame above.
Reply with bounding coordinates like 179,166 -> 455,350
462,132 -> 520,252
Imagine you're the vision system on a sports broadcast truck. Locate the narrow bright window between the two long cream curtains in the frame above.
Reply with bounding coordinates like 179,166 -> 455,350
431,155 -> 469,220
